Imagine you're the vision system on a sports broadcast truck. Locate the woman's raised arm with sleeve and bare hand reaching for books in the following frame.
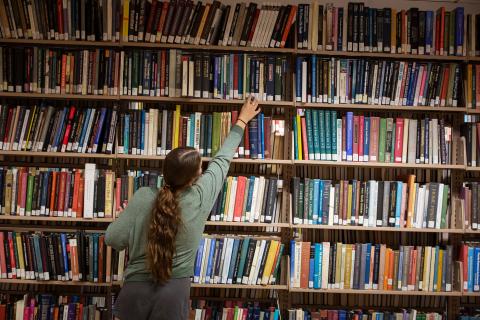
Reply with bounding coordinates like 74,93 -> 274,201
194,98 -> 260,214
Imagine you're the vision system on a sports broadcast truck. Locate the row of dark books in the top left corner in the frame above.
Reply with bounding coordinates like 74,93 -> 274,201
0,0 -> 122,41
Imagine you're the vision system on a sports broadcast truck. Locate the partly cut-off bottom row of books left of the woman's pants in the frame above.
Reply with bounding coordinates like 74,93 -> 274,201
0,294 -> 108,320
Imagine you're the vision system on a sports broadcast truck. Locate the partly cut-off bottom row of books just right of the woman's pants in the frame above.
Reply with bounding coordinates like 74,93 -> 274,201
192,301 -> 281,320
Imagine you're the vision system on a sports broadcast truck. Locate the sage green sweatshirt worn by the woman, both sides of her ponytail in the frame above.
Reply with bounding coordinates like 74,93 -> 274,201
105,126 -> 243,282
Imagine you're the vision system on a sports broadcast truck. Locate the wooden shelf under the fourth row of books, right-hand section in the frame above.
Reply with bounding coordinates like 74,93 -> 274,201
290,224 -> 464,234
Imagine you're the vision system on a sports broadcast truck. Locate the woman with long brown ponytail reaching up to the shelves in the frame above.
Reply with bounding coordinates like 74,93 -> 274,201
105,97 -> 260,320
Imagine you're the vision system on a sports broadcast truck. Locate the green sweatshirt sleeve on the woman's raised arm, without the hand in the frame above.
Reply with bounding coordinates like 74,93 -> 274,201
193,125 -> 243,215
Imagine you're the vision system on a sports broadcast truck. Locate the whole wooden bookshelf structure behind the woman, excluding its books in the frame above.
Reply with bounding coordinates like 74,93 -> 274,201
0,1 -> 480,319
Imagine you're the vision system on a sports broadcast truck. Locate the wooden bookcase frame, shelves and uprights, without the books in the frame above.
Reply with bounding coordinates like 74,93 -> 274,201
0,0 -> 480,319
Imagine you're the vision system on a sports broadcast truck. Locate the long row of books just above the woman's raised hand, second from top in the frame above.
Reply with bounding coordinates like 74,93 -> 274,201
0,47 -> 291,101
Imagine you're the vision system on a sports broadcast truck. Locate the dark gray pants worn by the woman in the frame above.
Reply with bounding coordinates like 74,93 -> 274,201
113,278 -> 190,320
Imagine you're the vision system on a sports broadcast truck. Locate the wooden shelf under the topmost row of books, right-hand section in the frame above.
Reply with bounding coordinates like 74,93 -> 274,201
295,49 -> 472,61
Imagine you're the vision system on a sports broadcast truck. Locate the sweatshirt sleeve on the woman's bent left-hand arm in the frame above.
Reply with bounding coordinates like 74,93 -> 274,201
105,188 -> 153,250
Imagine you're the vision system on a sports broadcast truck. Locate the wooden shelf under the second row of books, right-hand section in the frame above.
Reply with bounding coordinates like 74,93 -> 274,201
295,102 -> 466,113
